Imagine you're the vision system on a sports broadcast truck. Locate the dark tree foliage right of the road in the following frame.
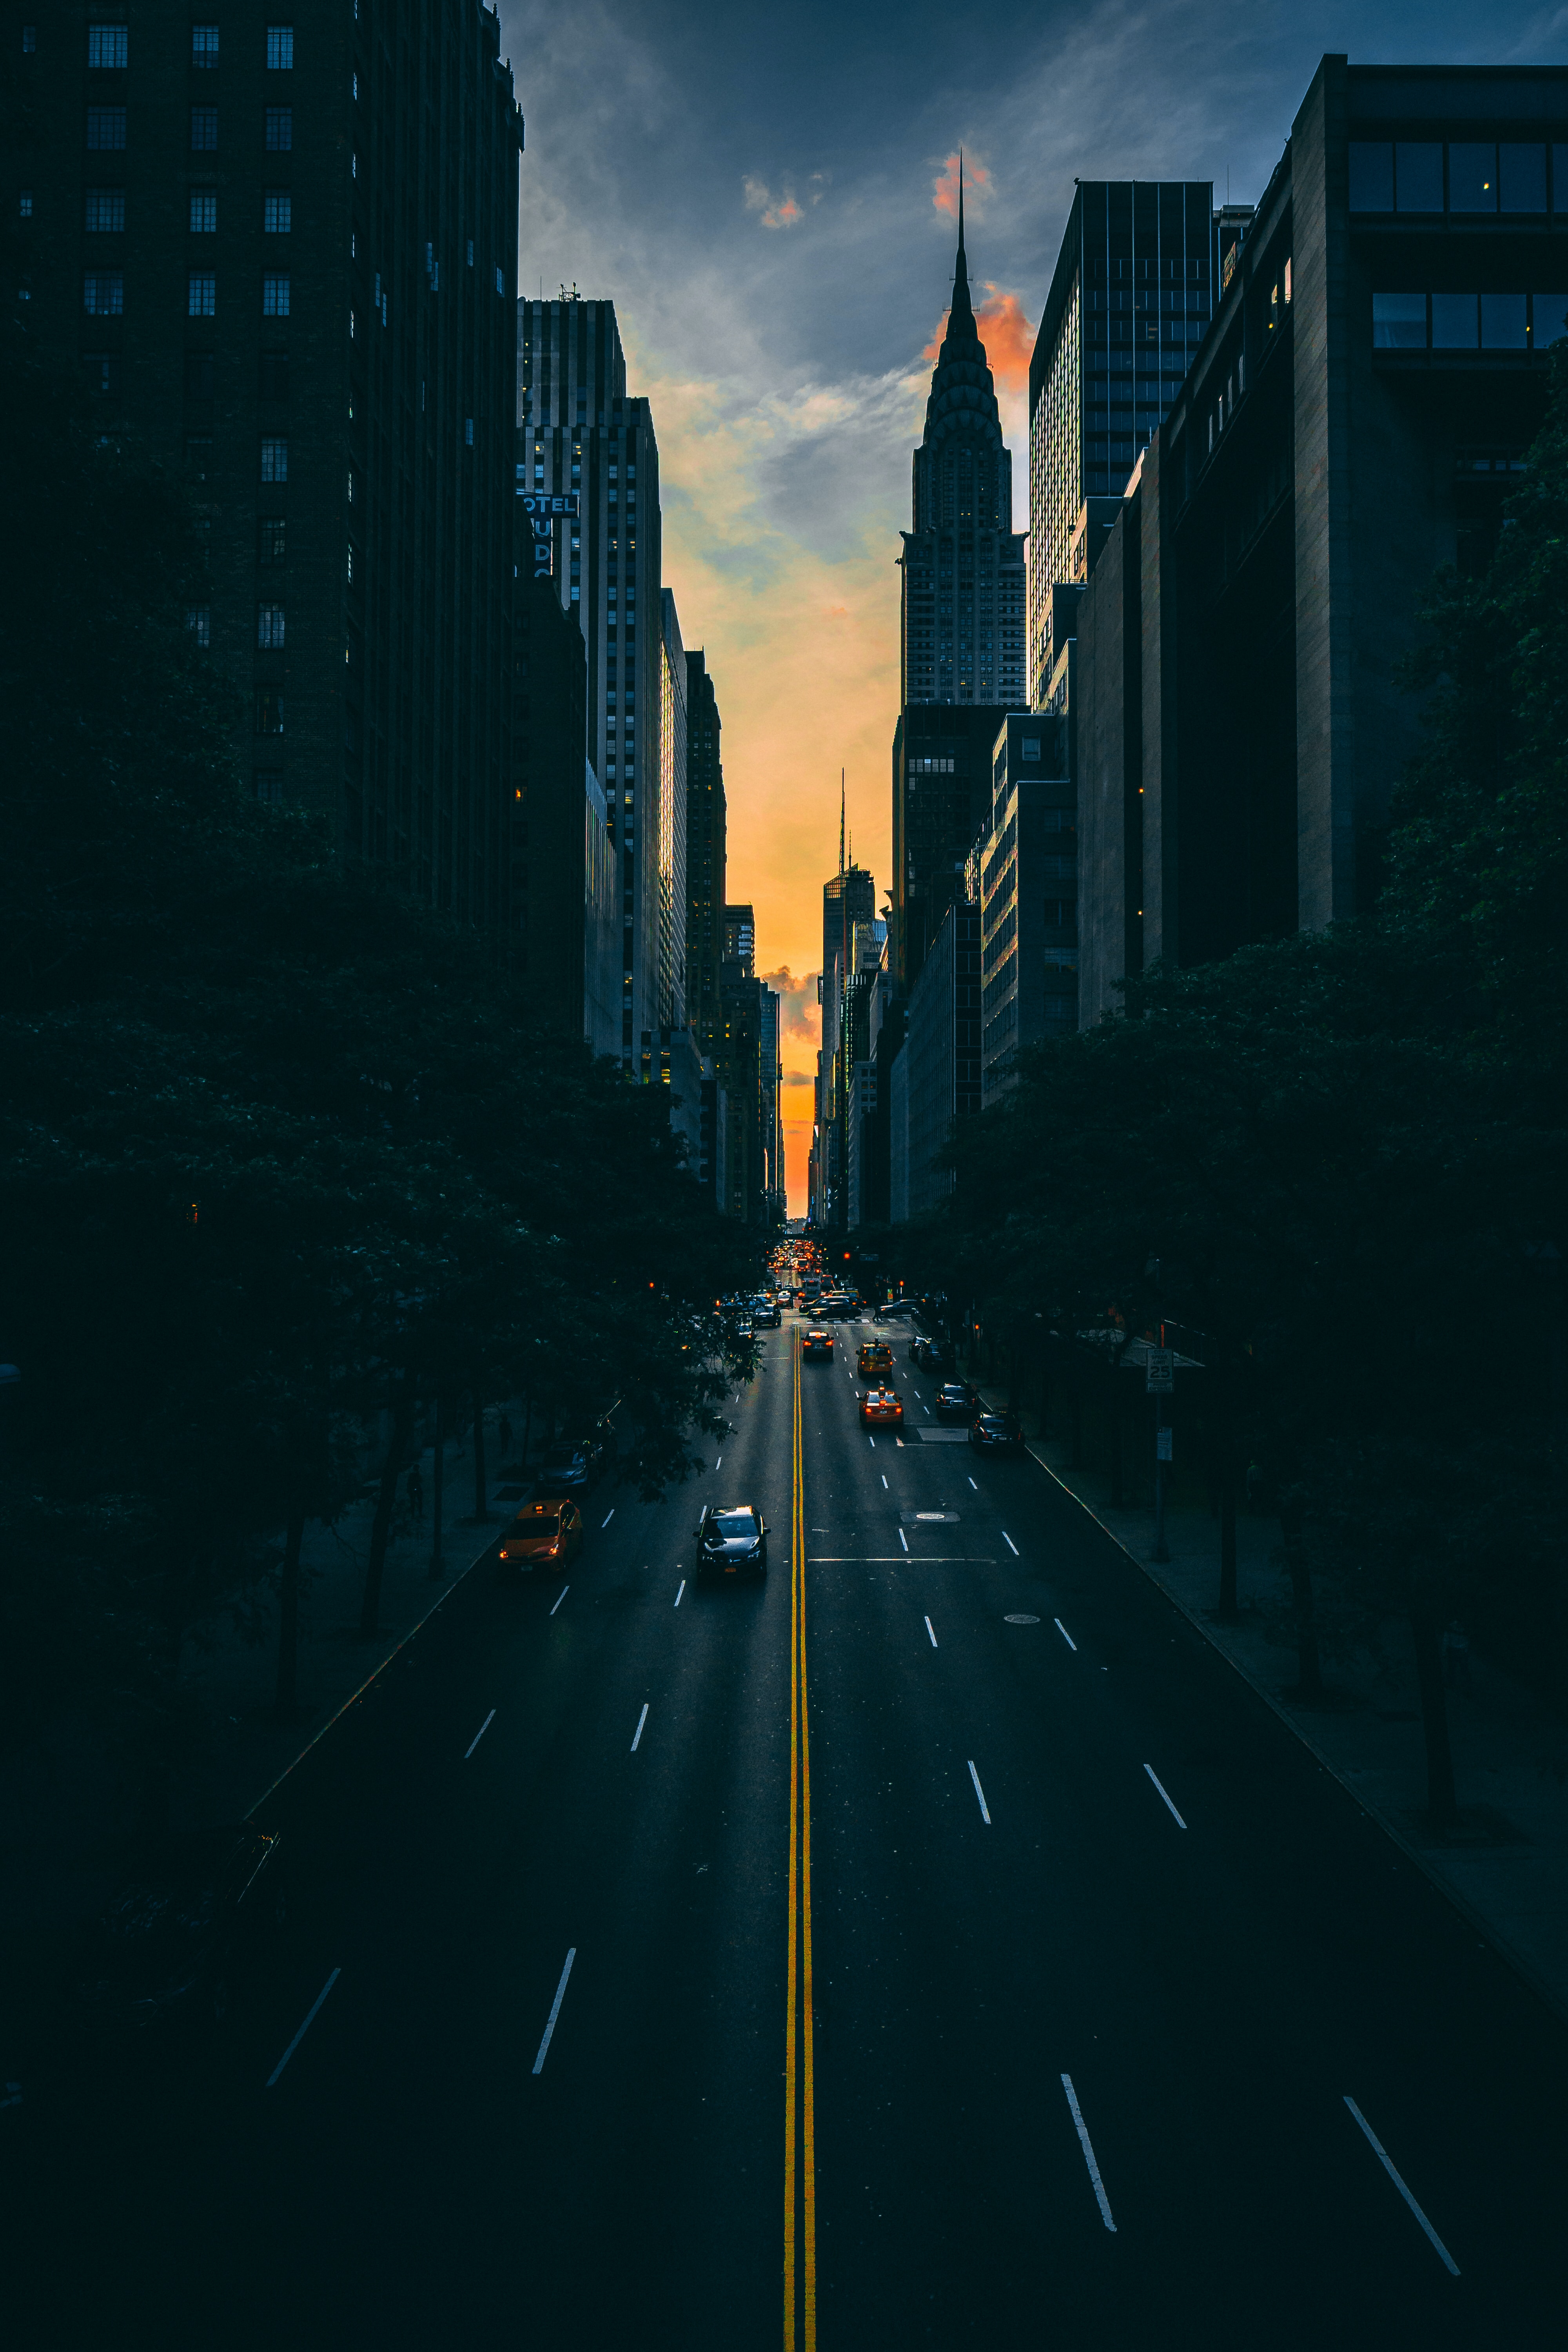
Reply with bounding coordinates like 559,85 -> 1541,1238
945,358 -> 1568,1813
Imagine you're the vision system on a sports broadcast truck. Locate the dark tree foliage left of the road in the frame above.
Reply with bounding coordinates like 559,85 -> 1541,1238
0,327 -> 755,1769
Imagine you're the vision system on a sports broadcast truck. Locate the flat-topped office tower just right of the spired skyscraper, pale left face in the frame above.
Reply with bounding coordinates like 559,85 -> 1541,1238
1020,179 -> 1234,710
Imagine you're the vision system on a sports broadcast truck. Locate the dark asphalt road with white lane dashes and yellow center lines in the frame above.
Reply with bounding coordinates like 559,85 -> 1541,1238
0,1319 -> 1568,2352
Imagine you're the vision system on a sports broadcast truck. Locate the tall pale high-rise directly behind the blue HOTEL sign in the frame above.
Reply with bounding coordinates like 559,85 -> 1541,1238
517,294 -> 670,1077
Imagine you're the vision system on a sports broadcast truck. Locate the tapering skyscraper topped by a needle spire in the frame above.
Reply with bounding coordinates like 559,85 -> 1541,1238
900,191 -> 1027,708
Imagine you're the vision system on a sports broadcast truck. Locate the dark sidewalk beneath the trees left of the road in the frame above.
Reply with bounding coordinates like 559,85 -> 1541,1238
0,1430 -> 526,1992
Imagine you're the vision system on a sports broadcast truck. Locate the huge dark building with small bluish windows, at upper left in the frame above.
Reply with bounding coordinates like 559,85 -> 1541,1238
17,0 -> 522,922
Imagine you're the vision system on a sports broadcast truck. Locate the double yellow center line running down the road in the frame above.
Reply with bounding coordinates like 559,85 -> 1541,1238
783,1331 -> 816,2352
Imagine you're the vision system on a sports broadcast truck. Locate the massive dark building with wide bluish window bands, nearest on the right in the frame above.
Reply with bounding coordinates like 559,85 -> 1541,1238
1077,56 -> 1568,1021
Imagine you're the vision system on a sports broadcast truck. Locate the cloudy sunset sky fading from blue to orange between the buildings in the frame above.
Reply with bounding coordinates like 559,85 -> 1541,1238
501,0 -> 1568,1216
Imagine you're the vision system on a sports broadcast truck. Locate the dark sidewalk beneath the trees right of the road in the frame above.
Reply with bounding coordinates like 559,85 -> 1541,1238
980,1388 -> 1568,2016
